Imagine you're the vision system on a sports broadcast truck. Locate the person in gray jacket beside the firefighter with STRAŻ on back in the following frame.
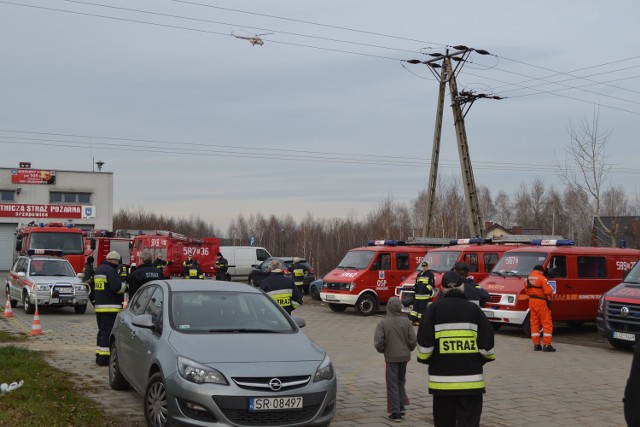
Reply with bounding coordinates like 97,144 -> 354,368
373,297 -> 416,421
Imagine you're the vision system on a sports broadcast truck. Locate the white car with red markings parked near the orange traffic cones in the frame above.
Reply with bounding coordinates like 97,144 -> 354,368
6,255 -> 90,314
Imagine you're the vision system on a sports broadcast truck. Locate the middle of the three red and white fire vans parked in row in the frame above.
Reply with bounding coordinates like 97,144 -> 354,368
396,238 -> 514,312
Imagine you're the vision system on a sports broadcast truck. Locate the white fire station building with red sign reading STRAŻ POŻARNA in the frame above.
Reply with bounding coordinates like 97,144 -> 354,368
0,162 -> 113,271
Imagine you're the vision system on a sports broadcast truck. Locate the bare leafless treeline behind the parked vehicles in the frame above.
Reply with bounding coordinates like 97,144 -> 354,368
114,178 -> 640,274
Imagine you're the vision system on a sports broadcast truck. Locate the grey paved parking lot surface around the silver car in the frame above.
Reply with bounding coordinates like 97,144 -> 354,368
0,274 -> 632,427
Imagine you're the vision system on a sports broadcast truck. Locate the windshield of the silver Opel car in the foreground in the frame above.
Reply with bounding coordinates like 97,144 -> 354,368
171,291 -> 295,333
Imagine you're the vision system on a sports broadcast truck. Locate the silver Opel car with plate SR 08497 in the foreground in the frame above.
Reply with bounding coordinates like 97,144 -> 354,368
109,280 -> 337,427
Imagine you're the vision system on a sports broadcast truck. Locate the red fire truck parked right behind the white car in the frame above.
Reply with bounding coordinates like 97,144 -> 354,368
16,222 -> 88,273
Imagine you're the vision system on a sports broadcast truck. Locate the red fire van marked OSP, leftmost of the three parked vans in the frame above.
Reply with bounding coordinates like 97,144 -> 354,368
320,240 -> 427,316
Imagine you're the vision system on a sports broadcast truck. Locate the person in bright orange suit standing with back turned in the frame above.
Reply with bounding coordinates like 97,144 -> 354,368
525,265 -> 556,352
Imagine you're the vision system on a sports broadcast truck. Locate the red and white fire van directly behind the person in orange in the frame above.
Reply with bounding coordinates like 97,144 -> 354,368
480,240 -> 640,335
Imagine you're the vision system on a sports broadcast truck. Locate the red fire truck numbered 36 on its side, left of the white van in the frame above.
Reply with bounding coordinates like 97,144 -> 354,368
131,230 -> 220,277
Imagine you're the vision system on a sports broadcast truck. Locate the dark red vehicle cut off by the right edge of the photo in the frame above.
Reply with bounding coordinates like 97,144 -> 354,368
596,263 -> 640,348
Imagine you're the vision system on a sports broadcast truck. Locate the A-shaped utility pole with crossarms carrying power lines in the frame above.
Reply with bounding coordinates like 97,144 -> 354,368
407,46 -> 501,241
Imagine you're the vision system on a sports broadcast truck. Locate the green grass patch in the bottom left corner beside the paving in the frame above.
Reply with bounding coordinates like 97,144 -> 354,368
0,345 -> 119,427
